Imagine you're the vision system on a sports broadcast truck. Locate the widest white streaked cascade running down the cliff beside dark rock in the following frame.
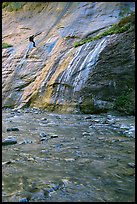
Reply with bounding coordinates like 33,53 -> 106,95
52,36 -> 109,101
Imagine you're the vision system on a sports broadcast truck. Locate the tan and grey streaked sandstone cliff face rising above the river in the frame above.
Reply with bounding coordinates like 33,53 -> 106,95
2,2 -> 135,114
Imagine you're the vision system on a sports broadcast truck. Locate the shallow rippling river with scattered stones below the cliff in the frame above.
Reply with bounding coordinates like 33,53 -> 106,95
2,109 -> 135,202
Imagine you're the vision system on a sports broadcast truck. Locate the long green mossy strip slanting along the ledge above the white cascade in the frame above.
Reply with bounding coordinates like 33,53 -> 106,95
74,13 -> 135,47
